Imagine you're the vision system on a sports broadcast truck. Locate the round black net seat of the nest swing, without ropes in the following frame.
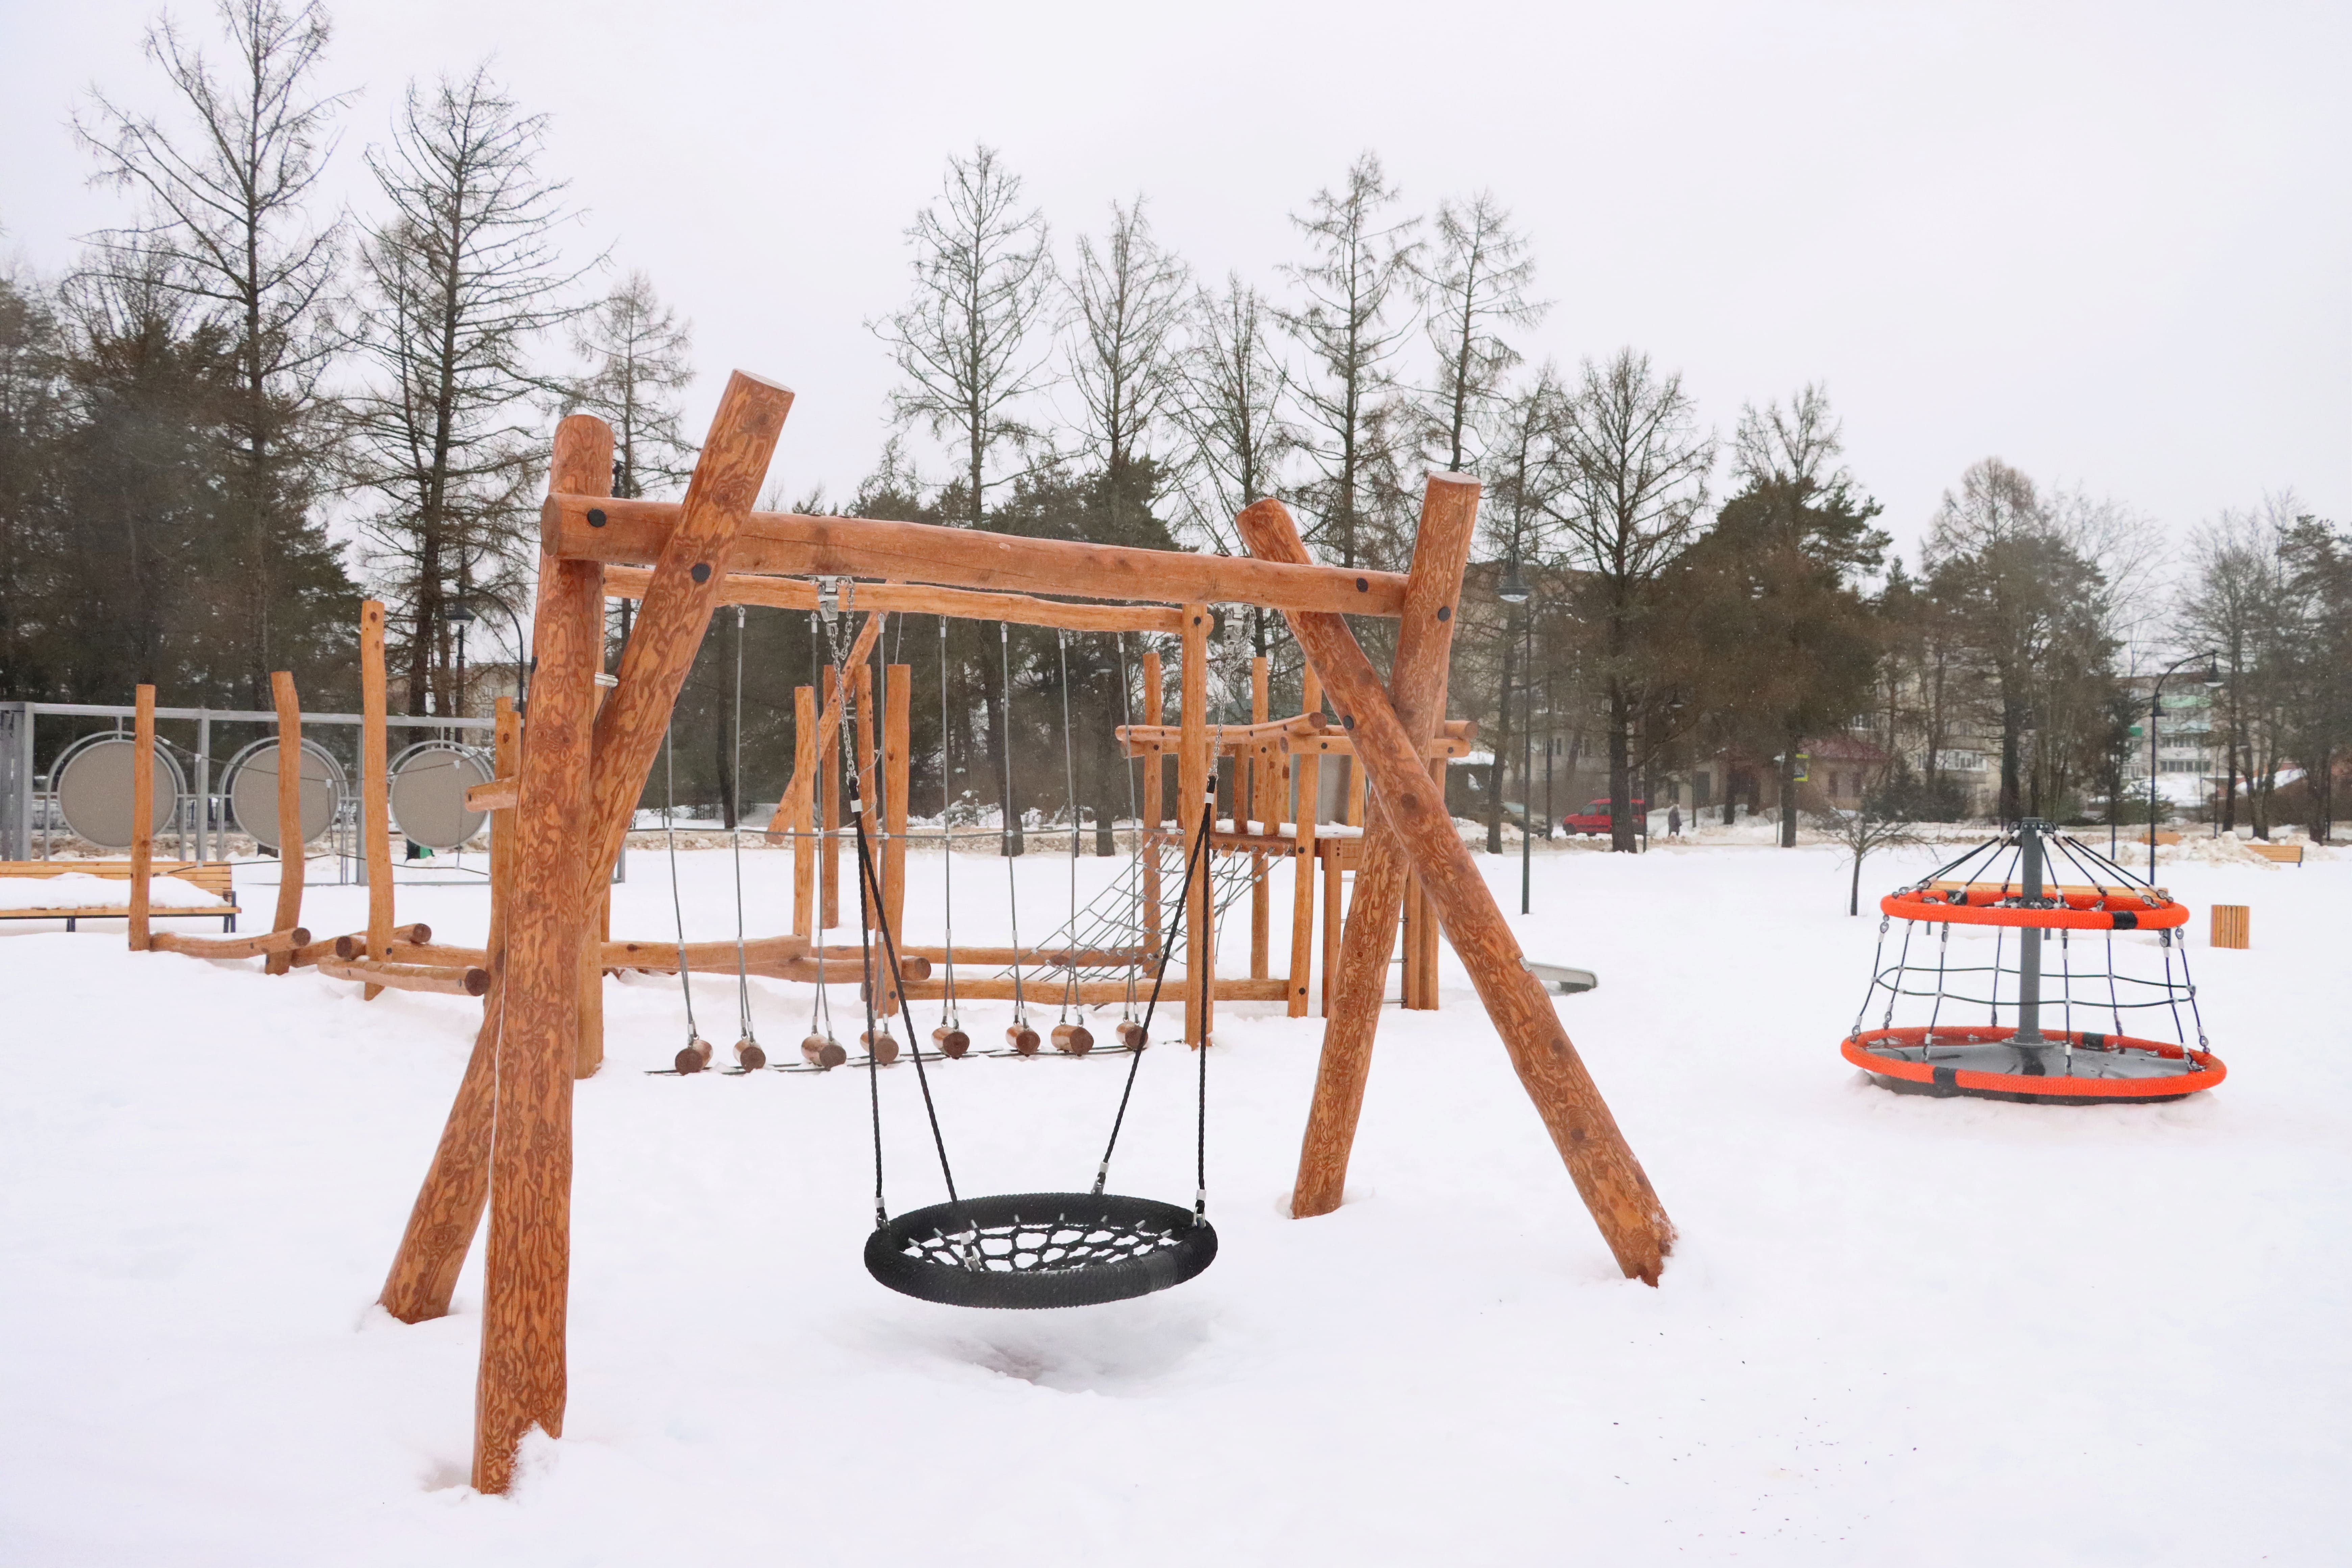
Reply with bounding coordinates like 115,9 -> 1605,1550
865,1192 -> 1216,1309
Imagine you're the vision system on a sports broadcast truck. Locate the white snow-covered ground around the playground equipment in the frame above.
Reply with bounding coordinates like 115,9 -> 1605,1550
0,846 -> 2352,1568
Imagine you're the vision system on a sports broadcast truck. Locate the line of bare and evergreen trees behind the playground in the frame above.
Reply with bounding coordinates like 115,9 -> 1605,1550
0,0 -> 2352,846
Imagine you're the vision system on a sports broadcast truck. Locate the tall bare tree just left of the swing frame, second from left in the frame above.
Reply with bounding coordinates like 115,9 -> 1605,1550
350,66 -> 602,712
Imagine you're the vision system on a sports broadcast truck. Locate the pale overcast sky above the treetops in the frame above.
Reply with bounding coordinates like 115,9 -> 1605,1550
0,0 -> 2352,564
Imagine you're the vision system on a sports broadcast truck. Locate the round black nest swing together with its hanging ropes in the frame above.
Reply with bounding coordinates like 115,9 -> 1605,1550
818,583 -> 1216,1309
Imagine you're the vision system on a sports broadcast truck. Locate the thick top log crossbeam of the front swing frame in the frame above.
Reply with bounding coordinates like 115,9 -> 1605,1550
539,494 -> 1404,616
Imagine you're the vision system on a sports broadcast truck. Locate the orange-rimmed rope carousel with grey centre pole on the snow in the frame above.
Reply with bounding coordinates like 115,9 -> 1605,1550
1839,820 -> 2227,1105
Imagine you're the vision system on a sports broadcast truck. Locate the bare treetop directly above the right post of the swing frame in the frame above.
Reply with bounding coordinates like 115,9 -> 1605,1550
1421,190 -> 1550,472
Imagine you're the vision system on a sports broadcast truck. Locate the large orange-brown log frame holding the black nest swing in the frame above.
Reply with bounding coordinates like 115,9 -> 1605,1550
381,371 -> 1672,1493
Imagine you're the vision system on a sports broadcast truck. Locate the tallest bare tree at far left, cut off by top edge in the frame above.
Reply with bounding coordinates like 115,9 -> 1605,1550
75,0 -> 348,705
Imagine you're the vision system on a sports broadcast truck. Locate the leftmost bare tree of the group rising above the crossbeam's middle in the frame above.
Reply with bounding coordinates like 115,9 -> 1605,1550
873,146 -> 1054,853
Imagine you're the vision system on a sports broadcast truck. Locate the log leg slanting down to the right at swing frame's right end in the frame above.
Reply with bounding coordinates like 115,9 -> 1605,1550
1240,501 -> 1675,1283
